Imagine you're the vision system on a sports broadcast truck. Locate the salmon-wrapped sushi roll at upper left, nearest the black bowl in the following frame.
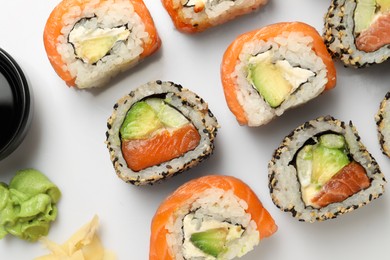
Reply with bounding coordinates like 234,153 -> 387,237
43,0 -> 161,89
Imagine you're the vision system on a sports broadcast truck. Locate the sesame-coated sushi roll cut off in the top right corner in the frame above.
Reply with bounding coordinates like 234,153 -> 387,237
324,0 -> 390,68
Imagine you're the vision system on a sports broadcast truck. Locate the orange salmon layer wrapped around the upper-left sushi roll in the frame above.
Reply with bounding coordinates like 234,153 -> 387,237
43,0 -> 161,86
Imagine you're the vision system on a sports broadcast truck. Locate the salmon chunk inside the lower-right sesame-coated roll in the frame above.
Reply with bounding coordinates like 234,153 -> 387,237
311,162 -> 370,207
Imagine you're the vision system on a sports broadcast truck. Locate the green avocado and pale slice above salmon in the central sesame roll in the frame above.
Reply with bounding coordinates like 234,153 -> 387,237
119,98 -> 189,140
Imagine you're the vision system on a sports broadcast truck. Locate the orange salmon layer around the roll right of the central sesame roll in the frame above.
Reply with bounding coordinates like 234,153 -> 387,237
221,22 -> 336,125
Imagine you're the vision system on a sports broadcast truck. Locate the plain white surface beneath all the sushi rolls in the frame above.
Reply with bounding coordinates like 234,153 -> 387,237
0,0 -> 390,260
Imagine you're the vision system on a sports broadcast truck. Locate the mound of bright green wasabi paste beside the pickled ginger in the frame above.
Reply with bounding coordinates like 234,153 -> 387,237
0,169 -> 61,242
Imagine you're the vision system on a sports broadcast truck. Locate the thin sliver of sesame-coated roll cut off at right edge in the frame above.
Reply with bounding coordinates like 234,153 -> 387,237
375,92 -> 390,157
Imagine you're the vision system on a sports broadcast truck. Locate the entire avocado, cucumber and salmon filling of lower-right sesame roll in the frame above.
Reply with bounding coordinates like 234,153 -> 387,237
293,132 -> 370,208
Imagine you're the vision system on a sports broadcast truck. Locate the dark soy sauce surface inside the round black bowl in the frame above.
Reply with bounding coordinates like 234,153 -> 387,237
0,70 -> 20,150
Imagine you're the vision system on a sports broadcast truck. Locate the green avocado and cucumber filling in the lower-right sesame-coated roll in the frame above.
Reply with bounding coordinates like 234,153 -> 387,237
296,133 -> 350,206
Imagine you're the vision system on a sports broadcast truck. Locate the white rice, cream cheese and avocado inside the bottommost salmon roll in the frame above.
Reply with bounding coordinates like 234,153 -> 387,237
166,188 -> 260,260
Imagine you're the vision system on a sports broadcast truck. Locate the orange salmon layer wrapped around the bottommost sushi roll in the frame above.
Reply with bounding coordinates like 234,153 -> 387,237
149,175 -> 278,260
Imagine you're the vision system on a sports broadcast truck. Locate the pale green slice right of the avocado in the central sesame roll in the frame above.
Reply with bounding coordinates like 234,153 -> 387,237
146,98 -> 189,128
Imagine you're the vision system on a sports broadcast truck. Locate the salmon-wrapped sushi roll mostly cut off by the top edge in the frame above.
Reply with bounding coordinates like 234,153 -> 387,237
162,0 -> 268,33
